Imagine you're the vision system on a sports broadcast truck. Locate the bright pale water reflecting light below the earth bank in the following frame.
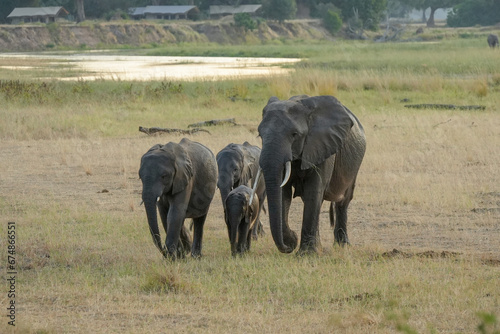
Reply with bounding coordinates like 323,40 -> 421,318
0,53 -> 300,80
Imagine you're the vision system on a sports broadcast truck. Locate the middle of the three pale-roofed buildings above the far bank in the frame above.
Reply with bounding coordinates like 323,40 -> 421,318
128,6 -> 200,20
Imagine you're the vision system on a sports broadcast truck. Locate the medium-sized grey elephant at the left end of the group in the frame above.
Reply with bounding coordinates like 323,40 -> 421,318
139,138 -> 217,259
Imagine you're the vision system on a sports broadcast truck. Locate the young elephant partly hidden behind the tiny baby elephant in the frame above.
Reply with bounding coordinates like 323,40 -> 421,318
217,142 -> 266,239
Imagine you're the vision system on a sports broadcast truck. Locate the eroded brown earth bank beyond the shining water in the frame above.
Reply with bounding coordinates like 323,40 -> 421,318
0,20 -> 329,52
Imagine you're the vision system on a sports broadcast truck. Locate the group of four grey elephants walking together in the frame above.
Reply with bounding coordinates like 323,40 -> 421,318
139,95 -> 366,259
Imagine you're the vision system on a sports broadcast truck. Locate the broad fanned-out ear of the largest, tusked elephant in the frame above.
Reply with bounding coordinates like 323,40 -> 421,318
300,96 -> 354,169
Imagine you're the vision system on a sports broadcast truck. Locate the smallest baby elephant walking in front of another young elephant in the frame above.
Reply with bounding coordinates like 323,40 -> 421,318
224,185 -> 259,256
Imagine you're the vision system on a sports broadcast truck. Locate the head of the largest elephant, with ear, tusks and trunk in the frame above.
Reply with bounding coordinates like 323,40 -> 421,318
258,95 -> 357,253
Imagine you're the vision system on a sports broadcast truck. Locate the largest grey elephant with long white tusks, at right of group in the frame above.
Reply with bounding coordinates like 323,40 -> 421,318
259,95 -> 366,253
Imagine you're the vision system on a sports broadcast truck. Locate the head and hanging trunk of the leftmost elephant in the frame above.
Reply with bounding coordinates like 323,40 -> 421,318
139,143 -> 193,255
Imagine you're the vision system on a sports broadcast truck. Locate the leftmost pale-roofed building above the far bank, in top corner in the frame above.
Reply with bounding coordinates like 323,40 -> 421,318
7,7 -> 69,24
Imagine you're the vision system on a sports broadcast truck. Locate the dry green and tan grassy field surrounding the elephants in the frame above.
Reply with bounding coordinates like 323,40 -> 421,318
0,30 -> 500,333
